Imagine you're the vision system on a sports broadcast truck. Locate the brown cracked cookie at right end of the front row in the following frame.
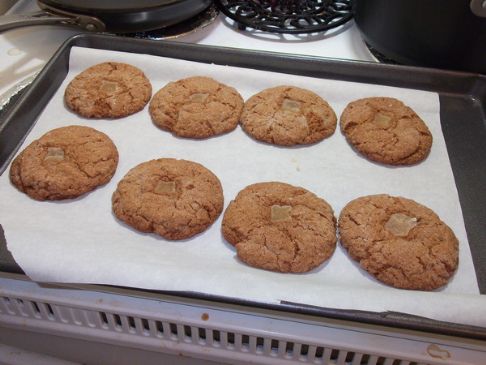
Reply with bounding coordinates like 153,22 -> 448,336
338,195 -> 459,290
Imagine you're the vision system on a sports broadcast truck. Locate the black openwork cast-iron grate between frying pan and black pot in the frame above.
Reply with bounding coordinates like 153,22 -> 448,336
215,0 -> 353,34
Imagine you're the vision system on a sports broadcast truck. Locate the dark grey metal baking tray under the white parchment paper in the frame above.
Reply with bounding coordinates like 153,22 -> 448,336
0,34 -> 486,339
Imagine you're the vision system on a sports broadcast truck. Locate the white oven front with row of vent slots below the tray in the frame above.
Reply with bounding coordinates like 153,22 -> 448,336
0,274 -> 486,365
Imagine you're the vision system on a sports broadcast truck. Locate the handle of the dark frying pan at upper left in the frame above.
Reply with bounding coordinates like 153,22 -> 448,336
0,11 -> 105,32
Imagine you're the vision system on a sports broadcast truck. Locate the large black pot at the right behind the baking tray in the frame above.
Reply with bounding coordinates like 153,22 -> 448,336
354,0 -> 486,74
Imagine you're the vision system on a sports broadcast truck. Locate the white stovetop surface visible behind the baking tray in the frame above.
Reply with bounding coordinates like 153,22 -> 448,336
0,0 -> 375,96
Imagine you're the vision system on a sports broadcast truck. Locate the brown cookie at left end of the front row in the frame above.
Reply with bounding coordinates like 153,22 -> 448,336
10,125 -> 118,200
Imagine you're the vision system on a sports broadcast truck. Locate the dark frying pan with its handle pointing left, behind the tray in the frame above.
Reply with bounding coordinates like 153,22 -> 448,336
0,0 -> 211,33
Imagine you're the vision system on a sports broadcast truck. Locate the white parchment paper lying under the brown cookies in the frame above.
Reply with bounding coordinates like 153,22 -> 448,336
0,48 -> 486,325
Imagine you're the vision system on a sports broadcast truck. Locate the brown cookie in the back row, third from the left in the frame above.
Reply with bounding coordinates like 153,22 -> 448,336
241,86 -> 337,146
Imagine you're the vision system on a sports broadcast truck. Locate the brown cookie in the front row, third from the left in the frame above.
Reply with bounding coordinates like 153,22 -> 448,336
222,182 -> 336,273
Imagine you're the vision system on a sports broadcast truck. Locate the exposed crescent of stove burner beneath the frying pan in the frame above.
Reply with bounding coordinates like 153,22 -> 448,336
118,4 -> 219,41
